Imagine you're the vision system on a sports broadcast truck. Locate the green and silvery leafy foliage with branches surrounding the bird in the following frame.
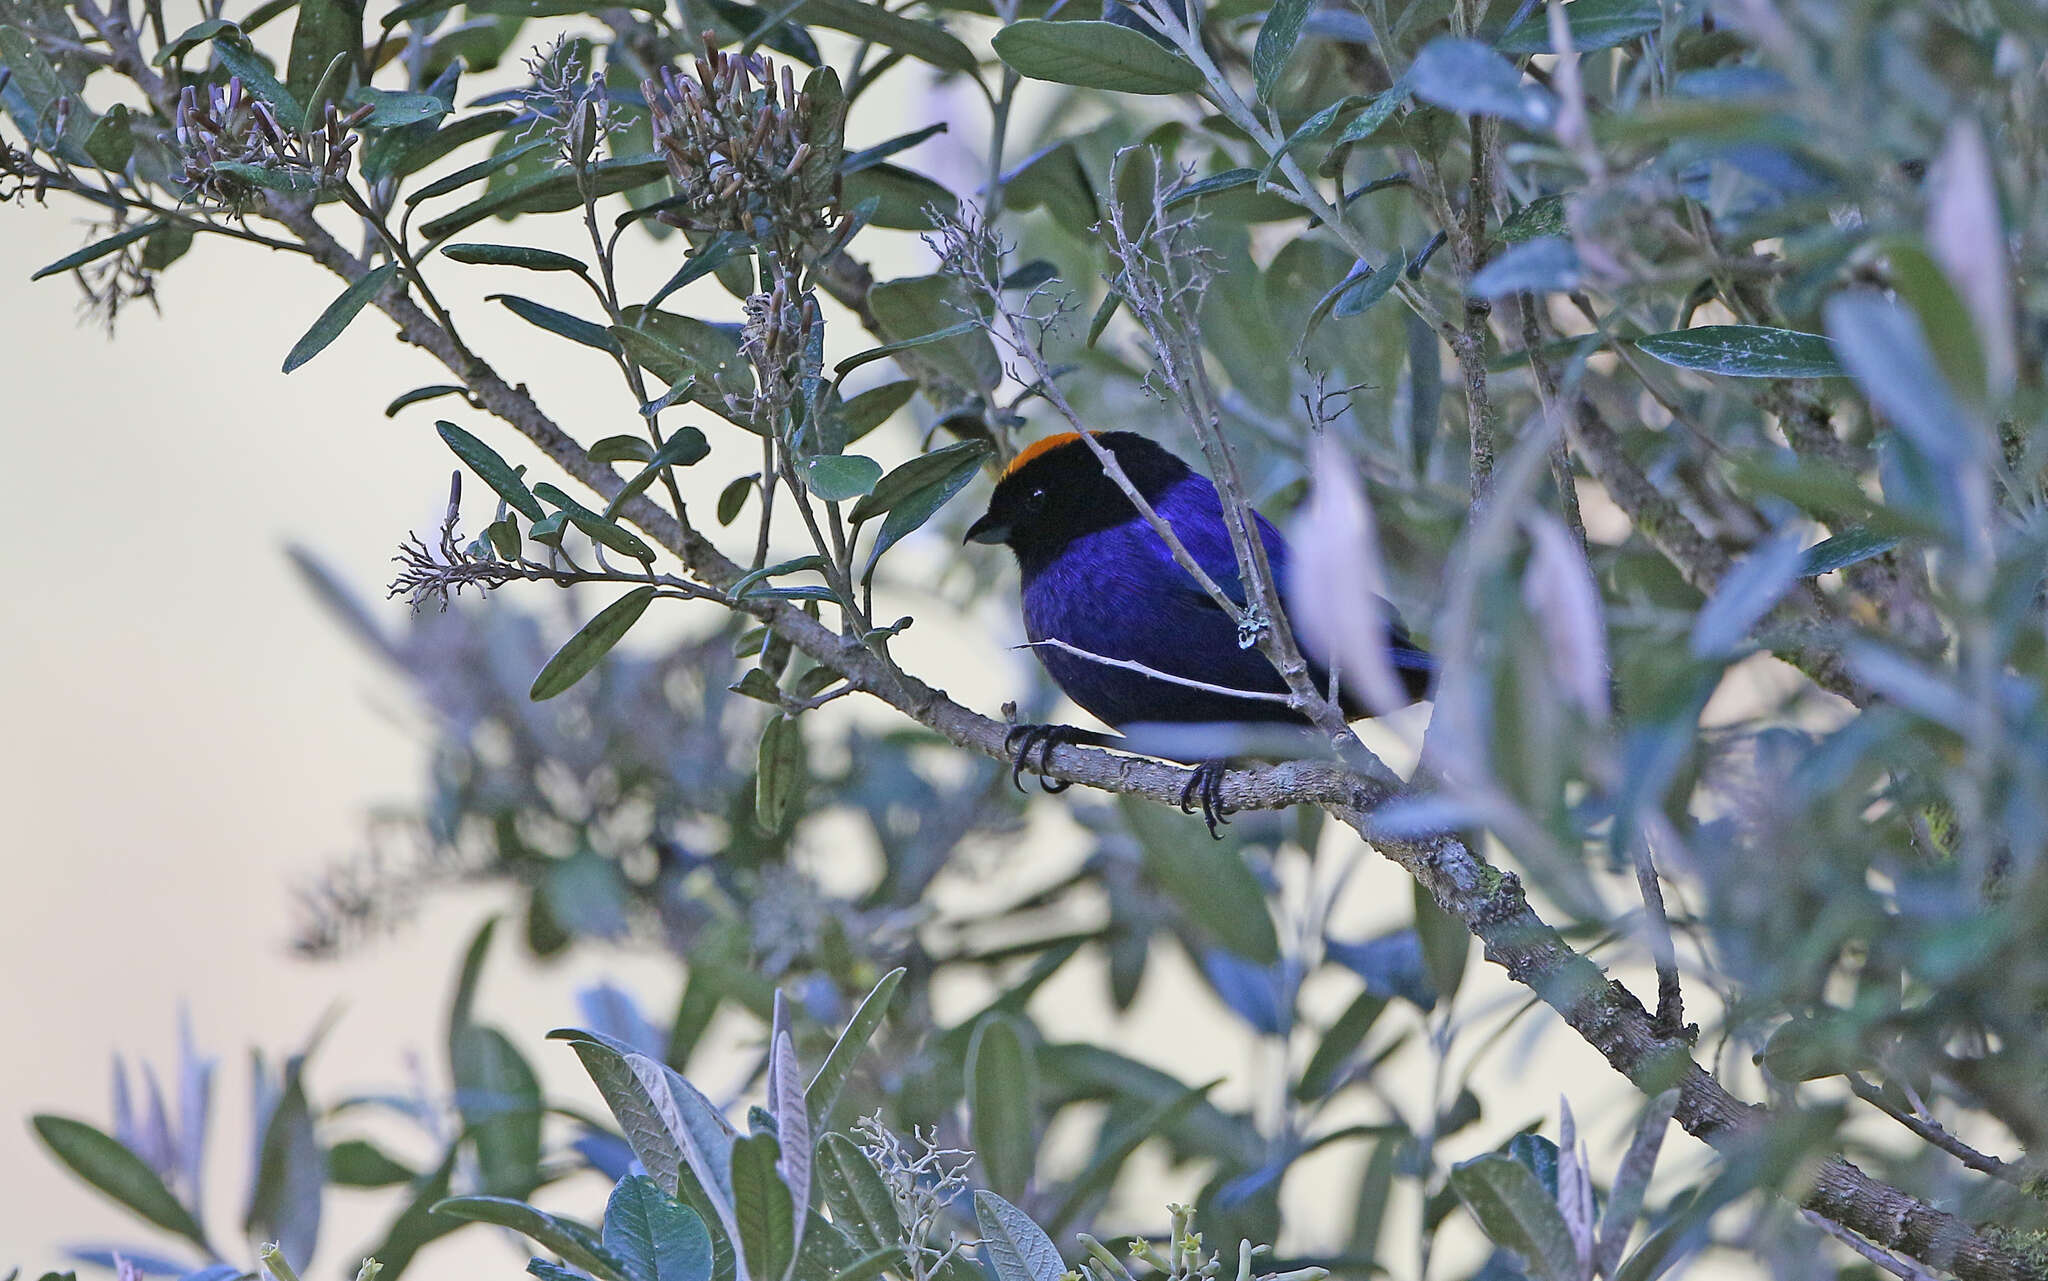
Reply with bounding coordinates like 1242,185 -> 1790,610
0,0 -> 2048,1281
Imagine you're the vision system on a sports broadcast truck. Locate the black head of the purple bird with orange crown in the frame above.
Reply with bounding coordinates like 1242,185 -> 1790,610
963,432 -> 1188,566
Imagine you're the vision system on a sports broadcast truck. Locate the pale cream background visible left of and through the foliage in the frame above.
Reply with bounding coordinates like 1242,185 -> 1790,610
0,114 -> 1761,1281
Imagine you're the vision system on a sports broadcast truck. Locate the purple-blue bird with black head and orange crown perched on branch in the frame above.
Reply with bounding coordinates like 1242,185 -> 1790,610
963,430 -> 1436,836
